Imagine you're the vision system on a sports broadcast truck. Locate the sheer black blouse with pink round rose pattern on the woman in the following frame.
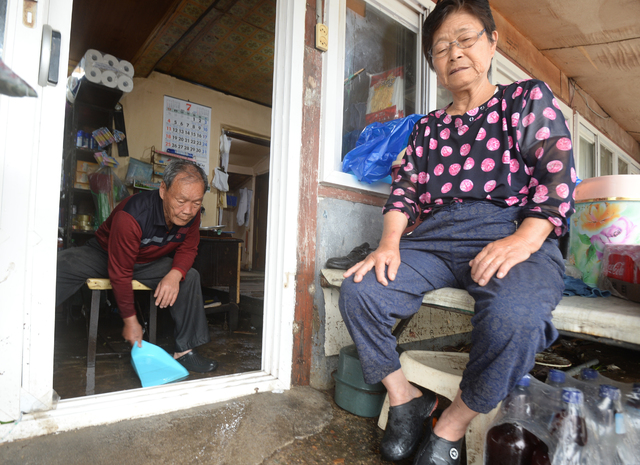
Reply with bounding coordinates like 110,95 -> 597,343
384,79 -> 576,237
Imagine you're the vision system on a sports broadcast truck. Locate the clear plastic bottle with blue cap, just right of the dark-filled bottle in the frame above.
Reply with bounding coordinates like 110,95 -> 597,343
549,387 -> 588,465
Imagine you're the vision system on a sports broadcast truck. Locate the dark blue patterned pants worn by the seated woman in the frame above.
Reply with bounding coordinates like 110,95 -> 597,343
340,201 -> 564,413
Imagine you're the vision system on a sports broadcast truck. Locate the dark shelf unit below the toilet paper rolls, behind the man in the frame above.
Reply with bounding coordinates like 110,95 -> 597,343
58,81 -> 122,248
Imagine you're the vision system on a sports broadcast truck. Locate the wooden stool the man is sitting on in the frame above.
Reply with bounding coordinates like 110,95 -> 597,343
86,278 -> 158,395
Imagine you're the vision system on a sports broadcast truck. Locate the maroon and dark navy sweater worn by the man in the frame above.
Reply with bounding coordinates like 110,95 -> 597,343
96,191 -> 200,318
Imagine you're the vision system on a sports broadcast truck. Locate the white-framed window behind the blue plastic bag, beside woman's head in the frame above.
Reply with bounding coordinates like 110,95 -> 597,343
320,0 -> 435,195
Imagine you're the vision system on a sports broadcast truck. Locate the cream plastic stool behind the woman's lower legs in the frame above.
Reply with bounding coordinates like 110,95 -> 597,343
378,350 -> 499,465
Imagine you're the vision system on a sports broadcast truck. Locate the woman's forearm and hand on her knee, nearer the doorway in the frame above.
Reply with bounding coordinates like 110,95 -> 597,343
343,211 -> 407,286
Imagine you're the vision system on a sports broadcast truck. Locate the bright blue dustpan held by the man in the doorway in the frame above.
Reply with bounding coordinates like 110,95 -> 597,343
131,341 -> 189,387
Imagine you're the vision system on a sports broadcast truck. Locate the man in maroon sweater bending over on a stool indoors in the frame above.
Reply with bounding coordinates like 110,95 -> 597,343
56,160 -> 218,373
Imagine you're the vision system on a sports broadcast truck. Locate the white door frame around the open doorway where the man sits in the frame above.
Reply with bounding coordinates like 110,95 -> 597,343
0,0 -> 306,441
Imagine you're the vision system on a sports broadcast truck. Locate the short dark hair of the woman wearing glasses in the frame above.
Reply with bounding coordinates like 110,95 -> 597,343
422,0 -> 496,70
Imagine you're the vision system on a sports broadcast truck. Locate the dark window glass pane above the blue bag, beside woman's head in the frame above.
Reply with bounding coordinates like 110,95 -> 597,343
341,2 -> 418,159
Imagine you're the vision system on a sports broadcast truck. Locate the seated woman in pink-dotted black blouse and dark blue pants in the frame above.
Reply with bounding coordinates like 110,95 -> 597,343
340,0 -> 576,464
